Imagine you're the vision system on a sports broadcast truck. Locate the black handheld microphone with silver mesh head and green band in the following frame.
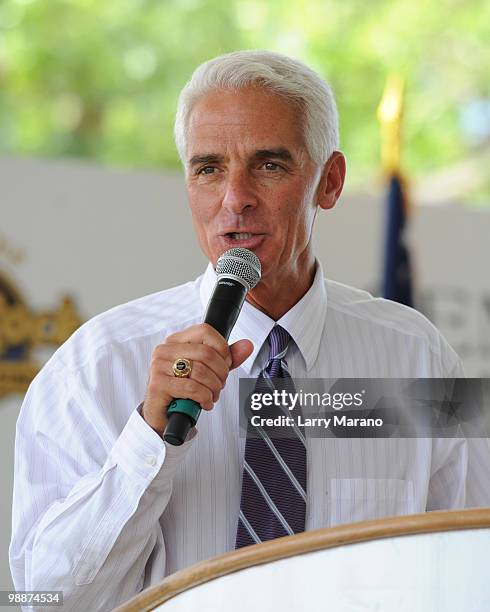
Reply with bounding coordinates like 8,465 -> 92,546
163,248 -> 261,446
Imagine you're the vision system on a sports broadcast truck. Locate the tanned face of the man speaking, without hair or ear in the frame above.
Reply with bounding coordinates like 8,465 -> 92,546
186,87 -> 320,280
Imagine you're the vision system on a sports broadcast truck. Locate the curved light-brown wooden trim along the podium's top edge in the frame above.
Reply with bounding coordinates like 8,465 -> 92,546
114,508 -> 490,612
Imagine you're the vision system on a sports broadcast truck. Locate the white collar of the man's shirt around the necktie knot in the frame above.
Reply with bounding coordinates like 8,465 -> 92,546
200,260 -> 327,375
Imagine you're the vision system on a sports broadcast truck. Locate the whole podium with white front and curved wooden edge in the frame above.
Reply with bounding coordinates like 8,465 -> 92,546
115,508 -> 490,612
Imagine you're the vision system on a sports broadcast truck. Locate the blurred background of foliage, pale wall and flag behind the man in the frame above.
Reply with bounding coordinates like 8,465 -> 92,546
0,0 -> 490,604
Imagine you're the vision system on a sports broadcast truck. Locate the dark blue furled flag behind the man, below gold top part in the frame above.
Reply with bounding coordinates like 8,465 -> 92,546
382,173 -> 413,306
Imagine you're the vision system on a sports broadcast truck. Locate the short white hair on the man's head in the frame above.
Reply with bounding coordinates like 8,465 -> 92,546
174,51 -> 339,166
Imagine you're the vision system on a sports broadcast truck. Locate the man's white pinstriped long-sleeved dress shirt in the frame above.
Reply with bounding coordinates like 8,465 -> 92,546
9,264 -> 490,611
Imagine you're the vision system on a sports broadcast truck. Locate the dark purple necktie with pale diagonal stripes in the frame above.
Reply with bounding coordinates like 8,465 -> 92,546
235,325 -> 306,548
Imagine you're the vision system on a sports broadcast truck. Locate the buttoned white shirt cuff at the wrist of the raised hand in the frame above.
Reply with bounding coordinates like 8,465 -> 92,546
107,406 -> 198,487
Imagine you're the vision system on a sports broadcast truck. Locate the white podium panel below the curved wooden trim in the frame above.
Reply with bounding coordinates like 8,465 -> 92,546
156,529 -> 490,612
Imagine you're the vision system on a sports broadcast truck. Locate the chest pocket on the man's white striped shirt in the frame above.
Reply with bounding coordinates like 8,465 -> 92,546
329,478 -> 416,526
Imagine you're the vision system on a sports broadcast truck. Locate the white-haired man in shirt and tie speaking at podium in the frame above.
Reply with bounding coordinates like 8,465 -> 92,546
10,51 -> 478,610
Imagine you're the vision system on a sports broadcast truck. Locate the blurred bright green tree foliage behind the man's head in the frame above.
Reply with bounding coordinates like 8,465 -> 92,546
0,0 -> 490,197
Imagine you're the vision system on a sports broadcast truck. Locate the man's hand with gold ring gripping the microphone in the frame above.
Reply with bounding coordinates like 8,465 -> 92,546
141,323 -> 253,435
